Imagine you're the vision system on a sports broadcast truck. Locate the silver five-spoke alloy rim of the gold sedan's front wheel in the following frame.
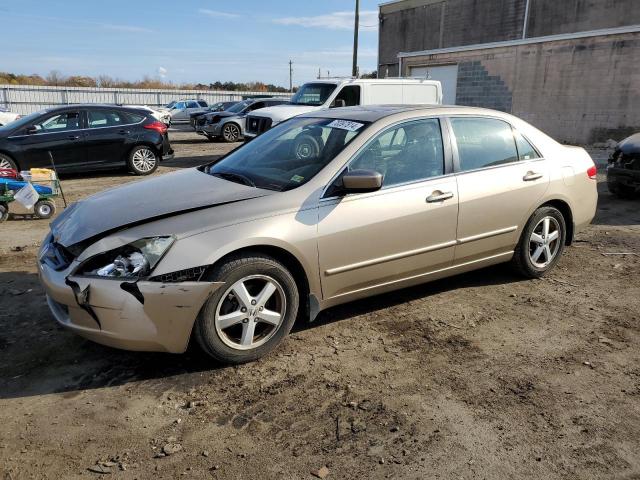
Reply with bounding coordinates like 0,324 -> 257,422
214,275 -> 287,350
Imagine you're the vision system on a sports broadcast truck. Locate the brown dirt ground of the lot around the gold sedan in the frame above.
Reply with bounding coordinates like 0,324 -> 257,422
0,128 -> 640,480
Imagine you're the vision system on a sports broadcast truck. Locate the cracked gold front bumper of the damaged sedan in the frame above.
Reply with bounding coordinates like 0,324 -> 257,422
39,262 -> 223,353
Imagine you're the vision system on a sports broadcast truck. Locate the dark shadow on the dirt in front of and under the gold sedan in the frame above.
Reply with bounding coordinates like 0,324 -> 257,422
0,267 -> 522,399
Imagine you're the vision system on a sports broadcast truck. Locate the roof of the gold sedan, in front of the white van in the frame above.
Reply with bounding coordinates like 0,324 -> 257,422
300,105 -> 506,122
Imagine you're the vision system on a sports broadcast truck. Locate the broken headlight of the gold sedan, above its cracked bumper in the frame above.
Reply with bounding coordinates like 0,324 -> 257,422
78,237 -> 175,278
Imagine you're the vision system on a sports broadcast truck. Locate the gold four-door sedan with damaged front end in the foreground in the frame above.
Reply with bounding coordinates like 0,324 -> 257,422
38,106 -> 597,363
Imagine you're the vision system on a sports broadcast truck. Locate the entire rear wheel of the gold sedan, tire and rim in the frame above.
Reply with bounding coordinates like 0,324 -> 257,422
511,207 -> 567,278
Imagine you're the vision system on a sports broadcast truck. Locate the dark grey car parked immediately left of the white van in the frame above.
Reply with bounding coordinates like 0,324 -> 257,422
196,98 -> 288,143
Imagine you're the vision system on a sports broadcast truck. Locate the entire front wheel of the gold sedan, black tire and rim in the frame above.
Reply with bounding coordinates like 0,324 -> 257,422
194,254 -> 300,364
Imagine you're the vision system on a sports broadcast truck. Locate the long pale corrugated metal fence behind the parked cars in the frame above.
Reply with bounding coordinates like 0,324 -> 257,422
0,85 -> 290,115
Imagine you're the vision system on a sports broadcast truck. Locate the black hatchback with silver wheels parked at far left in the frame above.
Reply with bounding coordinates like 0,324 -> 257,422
0,105 -> 173,175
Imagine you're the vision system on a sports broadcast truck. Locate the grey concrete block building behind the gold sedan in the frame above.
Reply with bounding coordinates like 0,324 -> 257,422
378,0 -> 640,144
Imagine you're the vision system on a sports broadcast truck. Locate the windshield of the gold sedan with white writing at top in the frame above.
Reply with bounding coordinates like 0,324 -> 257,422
204,118 -> 368,191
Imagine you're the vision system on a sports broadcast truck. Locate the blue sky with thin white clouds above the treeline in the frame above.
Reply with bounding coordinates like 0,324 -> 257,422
0,0 -> 380,87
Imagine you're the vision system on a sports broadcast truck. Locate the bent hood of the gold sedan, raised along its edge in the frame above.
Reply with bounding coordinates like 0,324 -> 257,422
51,168 -> 275,247
